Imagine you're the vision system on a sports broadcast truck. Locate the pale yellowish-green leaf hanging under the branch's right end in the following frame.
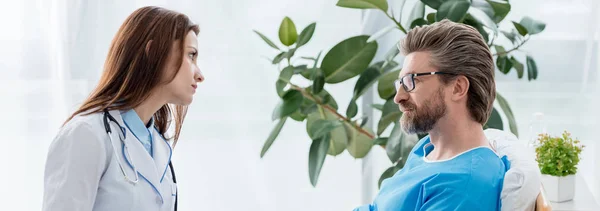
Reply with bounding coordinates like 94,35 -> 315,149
344,123 -> 373,158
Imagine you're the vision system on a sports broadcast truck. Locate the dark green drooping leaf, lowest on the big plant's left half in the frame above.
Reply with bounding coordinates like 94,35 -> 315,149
308,135 -> 330,187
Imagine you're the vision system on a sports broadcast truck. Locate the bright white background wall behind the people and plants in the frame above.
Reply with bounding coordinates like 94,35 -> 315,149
0,0 -> 600,211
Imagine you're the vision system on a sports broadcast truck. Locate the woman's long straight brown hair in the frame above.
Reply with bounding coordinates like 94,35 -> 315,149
65,6 -> 199,145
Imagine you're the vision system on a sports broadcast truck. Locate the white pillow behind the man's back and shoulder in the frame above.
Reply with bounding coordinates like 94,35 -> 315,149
484,129 -> 541,211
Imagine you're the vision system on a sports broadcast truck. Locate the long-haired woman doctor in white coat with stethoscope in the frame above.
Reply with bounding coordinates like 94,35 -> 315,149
43,7 -> 204,211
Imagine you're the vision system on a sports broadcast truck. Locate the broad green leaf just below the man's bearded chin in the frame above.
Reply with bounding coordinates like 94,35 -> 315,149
385,123 -> 419,163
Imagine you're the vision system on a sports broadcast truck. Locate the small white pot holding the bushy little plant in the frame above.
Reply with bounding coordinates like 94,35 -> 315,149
542,174 -> 575,202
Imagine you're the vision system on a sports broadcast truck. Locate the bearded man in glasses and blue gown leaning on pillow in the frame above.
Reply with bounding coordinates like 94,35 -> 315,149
355,20 -> 509,211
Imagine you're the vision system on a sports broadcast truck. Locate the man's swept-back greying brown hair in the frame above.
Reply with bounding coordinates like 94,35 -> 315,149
400,19 -> 496,125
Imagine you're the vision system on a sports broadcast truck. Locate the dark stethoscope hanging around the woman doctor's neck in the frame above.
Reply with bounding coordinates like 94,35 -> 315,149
104,109 -> 179,211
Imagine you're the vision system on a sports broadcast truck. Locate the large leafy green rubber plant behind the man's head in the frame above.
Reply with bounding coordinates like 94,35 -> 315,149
254,0 -> 546,186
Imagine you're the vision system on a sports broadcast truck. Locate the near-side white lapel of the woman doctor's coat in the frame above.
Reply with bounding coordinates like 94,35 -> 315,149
110,111 -> 165,202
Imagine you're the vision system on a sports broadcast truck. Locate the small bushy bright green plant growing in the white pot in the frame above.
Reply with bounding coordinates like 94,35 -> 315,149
535,131 -> 584,177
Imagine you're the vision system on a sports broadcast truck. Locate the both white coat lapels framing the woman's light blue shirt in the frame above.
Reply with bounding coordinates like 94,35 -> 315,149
109,110 -> 172,202
